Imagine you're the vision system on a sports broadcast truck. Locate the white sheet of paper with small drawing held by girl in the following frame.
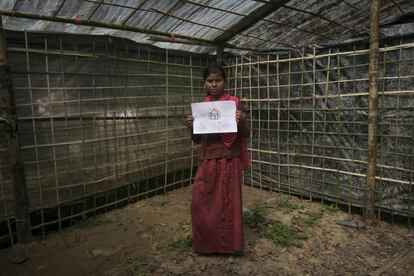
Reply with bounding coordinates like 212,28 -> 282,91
191,101 -> 237,134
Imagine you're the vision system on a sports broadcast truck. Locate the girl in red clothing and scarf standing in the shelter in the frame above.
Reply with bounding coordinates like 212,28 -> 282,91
185,64 -> 250,254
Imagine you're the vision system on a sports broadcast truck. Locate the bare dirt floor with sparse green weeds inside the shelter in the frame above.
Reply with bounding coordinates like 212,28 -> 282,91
0,187 -> 414,276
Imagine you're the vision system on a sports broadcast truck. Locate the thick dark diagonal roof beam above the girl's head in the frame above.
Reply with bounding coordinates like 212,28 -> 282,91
213,0 -> 289,44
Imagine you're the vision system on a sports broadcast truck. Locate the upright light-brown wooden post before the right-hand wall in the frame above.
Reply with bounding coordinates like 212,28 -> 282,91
364,0 -> 379,224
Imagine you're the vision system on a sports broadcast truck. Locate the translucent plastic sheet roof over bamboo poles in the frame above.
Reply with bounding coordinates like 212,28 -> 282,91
0,0 -> 414,53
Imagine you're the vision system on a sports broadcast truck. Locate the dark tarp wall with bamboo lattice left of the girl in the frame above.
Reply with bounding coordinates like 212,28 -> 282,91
0,32 -> 208,246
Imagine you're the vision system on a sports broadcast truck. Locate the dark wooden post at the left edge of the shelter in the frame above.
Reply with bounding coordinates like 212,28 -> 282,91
0,15 -> 32,244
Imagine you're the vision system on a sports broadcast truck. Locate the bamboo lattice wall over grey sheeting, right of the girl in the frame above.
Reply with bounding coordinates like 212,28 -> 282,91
227,41 -> 414,225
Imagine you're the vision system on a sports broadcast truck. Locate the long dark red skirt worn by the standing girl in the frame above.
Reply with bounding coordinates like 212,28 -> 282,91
191,158 -> 244,254
